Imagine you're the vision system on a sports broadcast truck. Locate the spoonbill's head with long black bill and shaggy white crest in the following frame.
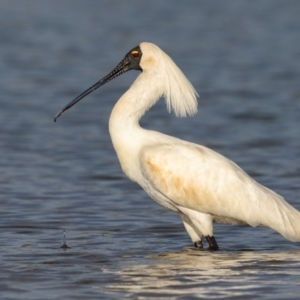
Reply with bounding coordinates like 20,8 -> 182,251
54,42 -> 197,122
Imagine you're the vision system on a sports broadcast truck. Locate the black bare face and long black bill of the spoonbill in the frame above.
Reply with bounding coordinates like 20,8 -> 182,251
54,46 -> 143,122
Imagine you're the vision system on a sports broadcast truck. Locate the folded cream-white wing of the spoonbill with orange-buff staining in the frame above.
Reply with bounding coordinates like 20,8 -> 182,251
140,142 -> 299,234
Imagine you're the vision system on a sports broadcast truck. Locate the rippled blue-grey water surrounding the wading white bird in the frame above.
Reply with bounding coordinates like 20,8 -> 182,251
0,0 -> 300,299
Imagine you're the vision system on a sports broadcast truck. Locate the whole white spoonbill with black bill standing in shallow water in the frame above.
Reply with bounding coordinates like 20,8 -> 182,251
54,42 -> 300,250
